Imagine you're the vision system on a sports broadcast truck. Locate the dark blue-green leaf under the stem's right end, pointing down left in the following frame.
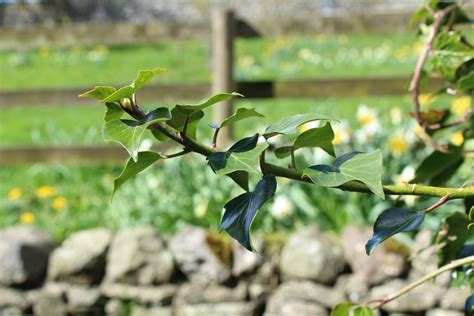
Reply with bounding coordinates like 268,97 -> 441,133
365,207 -> 425,255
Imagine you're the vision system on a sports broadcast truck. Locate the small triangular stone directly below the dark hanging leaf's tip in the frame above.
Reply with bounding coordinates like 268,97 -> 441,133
232,238 -> 264,277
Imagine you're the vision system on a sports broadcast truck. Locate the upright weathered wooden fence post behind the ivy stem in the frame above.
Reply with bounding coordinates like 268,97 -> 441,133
211,6 -> 235,146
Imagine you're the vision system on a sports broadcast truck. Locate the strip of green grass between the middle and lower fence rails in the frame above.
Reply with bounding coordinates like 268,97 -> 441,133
0,97 -> 426,146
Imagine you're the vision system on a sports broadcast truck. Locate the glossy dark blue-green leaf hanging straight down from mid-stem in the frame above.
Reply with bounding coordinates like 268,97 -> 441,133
221,175 -> 277,251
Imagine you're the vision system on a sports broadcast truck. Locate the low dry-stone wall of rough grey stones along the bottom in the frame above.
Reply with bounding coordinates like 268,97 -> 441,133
0,226 -> 470,316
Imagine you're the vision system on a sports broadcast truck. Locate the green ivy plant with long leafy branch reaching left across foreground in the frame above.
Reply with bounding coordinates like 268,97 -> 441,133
81,0 -> 474,316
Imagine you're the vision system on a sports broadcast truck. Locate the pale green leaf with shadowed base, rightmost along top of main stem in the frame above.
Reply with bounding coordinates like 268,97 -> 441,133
303,150 -> 385,199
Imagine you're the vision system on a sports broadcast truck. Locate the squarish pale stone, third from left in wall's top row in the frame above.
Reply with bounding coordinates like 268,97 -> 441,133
105,227 -> 174,285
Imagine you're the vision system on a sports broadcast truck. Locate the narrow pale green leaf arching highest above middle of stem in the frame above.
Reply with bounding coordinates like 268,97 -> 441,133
263,113 -> 335,139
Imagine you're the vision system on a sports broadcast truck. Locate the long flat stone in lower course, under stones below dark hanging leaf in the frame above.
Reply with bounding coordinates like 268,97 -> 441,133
174,282 -> 248,304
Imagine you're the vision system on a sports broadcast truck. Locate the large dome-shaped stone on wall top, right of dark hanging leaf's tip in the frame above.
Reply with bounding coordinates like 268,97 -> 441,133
280,225 -> 345,283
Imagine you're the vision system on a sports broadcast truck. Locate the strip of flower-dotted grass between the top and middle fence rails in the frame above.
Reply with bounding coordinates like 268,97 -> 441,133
0,33 -> 416,90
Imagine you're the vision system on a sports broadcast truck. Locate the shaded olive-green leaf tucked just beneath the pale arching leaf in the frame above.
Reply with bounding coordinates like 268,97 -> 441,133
275,123 -> 336,159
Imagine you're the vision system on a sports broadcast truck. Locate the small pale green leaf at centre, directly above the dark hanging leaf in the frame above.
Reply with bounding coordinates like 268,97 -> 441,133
215,143 -> 268,176
